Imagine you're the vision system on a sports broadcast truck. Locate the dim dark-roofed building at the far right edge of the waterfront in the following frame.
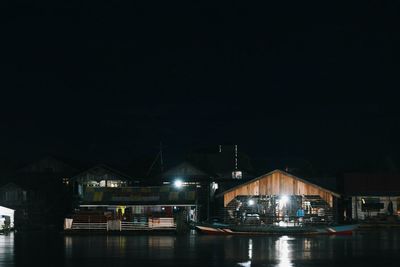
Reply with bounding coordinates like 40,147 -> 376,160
344,173 -> 400,220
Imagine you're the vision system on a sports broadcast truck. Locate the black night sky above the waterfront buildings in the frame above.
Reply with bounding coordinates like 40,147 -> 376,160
0,0 -> 400,165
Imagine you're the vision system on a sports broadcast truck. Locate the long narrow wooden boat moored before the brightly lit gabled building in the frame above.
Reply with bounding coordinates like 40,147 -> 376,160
196,224 -> 358,235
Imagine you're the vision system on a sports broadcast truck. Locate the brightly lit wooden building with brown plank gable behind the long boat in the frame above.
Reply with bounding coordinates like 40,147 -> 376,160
219,170 -> 339,224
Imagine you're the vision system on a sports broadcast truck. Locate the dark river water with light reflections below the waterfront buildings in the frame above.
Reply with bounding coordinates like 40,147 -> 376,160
0,230 -> 400,267
